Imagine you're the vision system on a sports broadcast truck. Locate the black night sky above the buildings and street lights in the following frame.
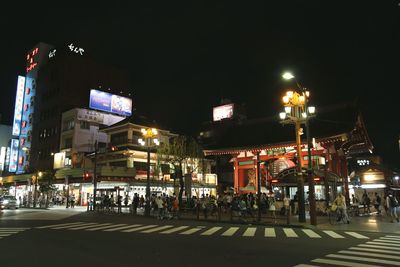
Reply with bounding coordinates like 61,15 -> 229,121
0,0 -> 400,167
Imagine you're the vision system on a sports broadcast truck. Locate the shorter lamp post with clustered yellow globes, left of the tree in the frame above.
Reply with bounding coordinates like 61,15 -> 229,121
138,128 -> 160,216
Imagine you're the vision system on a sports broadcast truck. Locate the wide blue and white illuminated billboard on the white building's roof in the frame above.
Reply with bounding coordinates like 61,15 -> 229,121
89,89 -> 132,116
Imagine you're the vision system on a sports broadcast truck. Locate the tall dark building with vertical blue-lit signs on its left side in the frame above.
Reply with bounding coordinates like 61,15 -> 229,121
13,43 -> 130,173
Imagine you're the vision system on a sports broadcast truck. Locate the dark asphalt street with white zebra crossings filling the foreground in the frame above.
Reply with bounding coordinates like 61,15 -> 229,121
0,209 -> 400,266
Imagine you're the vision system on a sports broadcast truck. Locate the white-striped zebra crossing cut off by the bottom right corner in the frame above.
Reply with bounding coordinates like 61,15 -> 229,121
295,235 -> 400,267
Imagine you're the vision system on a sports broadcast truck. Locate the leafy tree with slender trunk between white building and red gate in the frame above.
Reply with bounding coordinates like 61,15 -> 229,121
157,136 -> 204,206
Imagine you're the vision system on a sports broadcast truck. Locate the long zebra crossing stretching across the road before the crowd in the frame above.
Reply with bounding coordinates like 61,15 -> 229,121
36,222 -> 370,241
